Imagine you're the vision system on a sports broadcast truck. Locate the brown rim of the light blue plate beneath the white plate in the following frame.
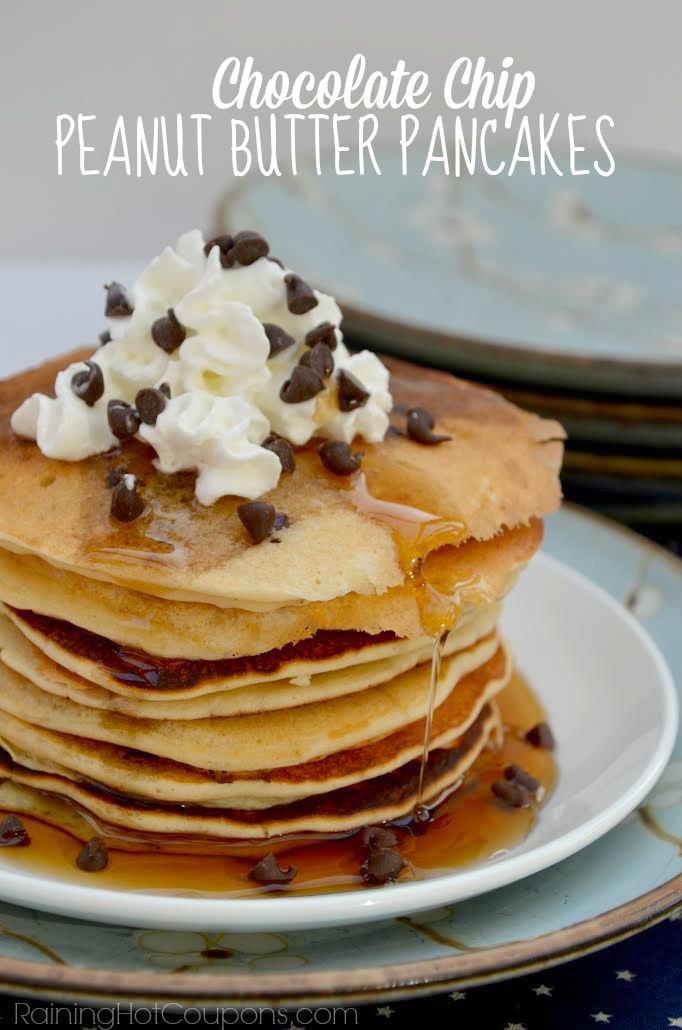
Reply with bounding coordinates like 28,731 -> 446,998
0,504 -> 682,1005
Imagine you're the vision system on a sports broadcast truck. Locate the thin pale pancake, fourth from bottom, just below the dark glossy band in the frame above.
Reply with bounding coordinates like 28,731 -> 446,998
0,605 -> 500,720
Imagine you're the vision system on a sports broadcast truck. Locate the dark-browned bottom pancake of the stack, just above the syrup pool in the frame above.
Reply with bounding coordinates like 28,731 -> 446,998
0,705 -> 500,840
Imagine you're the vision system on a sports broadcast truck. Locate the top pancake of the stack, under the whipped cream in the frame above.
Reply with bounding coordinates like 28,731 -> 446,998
0,351 -> 564,611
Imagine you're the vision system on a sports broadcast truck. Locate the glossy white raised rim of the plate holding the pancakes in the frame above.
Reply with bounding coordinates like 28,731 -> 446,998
0,553 -> 679,933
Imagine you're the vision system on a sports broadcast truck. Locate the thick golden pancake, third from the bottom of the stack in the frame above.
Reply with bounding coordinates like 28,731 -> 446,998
0,634 -> 500,773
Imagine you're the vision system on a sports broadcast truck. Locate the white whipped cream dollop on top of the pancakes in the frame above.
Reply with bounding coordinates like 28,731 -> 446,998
11,231 -> 393,506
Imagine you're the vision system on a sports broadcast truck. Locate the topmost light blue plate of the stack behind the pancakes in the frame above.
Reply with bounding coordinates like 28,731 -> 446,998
218,150 -> 682,398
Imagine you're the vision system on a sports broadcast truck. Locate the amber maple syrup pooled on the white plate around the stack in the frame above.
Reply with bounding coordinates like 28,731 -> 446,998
0,675 -> 556,896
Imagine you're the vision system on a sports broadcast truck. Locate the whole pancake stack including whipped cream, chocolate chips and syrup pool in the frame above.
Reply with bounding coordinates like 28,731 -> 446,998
0,232 -> 564,891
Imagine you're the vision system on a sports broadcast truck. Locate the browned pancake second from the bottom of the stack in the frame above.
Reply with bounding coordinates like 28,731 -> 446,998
0,648 -> 510,811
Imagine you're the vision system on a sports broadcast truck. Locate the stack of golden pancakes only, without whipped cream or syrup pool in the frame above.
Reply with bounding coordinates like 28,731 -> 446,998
0,354 -> 562,840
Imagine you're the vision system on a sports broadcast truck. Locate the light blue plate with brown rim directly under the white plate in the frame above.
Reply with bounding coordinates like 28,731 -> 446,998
0,509 -> 682,1004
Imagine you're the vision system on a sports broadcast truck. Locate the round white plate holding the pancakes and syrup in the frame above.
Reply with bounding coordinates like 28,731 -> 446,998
0,554 -> 678,931
